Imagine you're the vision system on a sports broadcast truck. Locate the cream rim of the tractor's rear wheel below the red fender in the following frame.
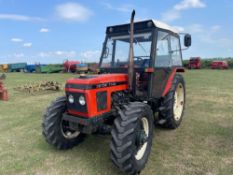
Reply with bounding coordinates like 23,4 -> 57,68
173,83 -> 184,121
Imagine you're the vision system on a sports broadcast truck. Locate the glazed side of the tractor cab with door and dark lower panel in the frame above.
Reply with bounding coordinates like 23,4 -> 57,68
151,30 -> 182,98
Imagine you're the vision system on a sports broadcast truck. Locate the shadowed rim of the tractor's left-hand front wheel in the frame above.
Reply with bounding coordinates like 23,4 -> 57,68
60,120 -> 80,139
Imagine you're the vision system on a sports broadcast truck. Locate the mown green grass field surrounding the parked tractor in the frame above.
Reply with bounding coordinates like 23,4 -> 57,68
0,70 -> 233,175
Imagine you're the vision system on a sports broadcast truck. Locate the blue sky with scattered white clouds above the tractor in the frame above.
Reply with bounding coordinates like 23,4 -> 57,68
0,0 -> 233,63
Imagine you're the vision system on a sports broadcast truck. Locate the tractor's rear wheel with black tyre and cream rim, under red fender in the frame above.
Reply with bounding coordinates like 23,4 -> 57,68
159,74 -> 185,129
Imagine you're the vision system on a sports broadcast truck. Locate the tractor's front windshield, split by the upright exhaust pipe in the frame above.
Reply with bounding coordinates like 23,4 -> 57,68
101,32 -> 152,68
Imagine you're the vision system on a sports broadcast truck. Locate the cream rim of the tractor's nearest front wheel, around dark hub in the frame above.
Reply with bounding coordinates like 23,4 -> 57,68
135,117 -> 149,160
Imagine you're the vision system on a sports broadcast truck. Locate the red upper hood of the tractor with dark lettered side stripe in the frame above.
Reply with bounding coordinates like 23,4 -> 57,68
66,74 -> 128,90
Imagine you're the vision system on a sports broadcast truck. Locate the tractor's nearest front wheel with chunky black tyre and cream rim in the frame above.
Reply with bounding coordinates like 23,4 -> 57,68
110,102 -> 153,174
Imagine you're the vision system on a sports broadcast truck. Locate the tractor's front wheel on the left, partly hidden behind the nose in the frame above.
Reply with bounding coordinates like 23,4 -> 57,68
42,96 -> 85,149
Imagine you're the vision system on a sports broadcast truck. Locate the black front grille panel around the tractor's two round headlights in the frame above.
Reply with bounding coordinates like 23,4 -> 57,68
66,92 -> 87,113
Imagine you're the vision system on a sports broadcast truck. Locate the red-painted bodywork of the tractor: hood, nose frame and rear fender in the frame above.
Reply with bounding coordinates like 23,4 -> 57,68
65,68 -> 184,118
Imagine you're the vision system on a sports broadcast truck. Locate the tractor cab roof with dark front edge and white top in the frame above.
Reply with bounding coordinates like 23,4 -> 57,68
106,19 -> 179,34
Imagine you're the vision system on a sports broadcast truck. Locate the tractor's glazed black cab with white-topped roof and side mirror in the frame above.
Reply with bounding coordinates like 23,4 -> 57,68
99,20 -> 191,100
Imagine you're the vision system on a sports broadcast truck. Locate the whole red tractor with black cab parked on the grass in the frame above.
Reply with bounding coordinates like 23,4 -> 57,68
42,11 -> 191,174
